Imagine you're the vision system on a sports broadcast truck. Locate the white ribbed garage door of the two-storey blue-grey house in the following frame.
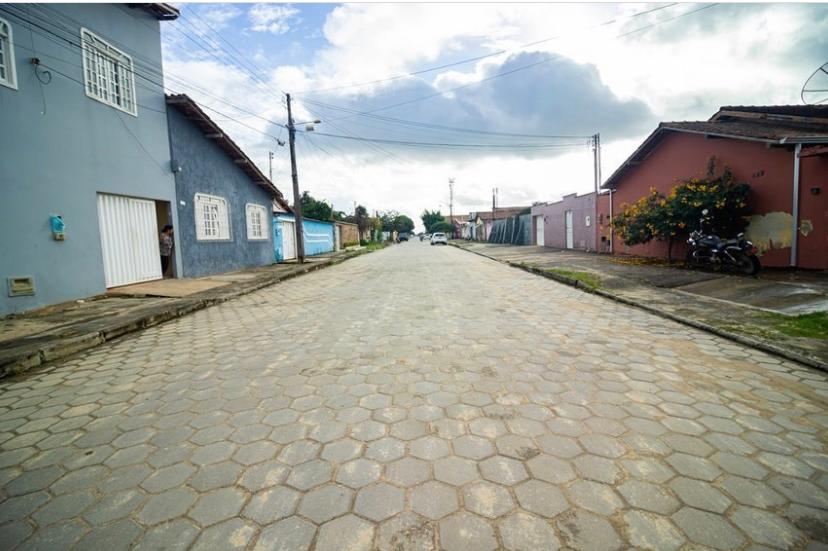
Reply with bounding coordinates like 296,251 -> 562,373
98,193 -> 162,287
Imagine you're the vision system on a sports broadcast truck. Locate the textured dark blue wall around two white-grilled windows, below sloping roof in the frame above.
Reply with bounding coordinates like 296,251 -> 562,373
168,106 -> 273,277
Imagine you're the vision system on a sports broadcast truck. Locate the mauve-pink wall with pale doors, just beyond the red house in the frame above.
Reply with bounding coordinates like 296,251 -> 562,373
532,193 -> 595,251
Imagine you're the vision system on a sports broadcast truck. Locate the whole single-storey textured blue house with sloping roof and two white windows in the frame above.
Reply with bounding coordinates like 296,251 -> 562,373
167,94 -> 289,277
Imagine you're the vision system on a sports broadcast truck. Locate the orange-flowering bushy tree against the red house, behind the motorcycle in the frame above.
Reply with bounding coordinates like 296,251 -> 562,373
612,169 -> 750,260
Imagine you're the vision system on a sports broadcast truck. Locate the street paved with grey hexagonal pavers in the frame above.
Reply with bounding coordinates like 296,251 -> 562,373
0,242 -> 828,551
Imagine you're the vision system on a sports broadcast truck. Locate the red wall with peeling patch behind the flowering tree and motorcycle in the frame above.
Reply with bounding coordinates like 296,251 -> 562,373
613,132 -> 828,269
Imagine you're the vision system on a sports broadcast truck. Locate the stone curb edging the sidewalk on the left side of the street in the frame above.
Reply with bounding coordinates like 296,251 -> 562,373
0,249 -> 382,379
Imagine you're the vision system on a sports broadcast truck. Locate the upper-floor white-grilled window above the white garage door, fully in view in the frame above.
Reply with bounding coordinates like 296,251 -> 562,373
81,29 -> 138,115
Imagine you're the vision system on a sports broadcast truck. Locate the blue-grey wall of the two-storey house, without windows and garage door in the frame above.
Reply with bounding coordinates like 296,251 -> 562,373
0,4 -> 180,315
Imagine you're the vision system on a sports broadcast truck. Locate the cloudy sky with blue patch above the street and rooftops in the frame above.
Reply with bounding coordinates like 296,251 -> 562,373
162,3 -> 828,230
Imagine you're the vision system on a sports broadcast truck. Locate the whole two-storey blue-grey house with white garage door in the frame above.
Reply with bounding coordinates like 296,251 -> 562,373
0,4 -> 181,315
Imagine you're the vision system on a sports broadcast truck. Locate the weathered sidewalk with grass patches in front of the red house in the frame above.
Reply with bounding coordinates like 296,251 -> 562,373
452,241 -> 828,370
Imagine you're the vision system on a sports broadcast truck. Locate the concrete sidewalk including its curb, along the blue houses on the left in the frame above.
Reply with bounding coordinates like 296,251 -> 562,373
0,249 -> 369,377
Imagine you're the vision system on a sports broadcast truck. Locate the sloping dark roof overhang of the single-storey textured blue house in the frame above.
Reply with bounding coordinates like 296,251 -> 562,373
167,94 -> 292,212
